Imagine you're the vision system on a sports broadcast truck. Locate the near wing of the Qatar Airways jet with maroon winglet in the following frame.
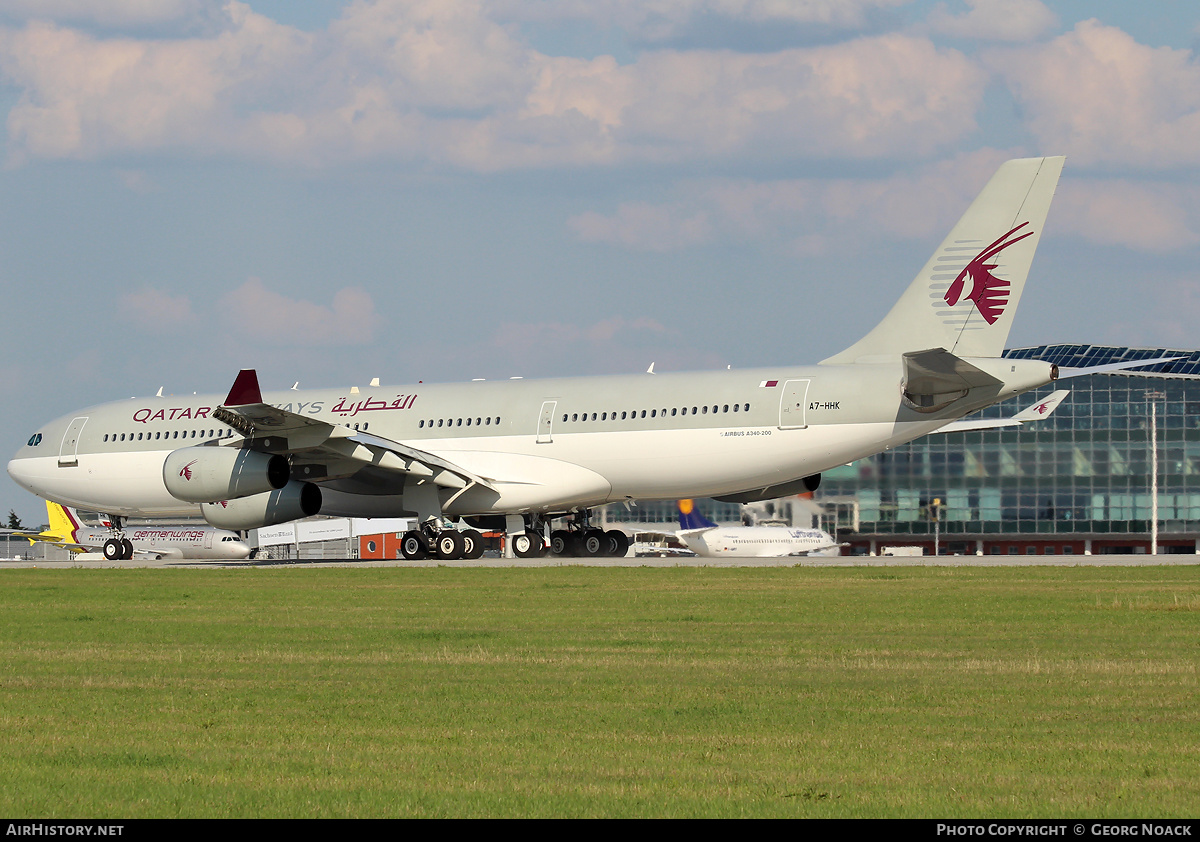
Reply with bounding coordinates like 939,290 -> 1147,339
212,368 -> 492,489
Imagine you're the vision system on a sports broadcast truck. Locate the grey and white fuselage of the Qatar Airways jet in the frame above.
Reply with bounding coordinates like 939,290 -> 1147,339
8,357 -> 1050,517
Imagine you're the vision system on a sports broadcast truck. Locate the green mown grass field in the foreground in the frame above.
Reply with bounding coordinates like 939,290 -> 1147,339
0,567 -> 1200,818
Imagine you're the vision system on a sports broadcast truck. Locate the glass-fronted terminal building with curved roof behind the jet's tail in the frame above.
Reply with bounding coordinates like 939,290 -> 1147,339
610,345 -> 1200,555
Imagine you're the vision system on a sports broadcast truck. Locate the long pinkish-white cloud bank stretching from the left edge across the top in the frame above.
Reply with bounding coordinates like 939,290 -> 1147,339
0,0 -> 986,170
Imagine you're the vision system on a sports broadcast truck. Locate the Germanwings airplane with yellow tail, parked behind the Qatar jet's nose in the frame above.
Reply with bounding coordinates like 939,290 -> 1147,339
5,500 -> 250,561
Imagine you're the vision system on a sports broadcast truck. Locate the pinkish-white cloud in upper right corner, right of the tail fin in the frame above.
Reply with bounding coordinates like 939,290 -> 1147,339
986,20 -> 1200,168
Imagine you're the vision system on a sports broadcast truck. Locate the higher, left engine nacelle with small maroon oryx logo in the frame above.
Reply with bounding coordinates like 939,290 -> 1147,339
162,447 -> 292,503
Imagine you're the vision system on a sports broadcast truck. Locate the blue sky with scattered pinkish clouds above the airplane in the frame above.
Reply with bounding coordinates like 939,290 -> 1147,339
0,0 -> 1200,523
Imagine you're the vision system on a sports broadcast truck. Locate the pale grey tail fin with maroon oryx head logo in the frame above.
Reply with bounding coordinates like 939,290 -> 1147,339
822,157 -> 1066,363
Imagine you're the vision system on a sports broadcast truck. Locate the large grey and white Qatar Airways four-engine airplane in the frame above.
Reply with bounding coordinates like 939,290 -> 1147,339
8,157 -> 1080,559
